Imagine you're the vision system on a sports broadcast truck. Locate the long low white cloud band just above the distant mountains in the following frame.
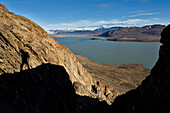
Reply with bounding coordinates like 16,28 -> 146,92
46,19 -> 151,29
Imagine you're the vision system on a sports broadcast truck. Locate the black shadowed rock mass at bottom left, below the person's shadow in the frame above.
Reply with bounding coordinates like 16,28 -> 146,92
0,64 -> 76,113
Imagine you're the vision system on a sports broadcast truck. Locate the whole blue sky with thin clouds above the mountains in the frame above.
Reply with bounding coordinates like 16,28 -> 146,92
0,0 -> 170,30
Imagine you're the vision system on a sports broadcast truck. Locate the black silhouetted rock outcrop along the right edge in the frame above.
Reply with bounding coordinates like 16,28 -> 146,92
109,25 -> 170,113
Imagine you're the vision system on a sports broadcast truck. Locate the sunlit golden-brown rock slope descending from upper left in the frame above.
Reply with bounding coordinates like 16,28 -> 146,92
0,4 -> 118,103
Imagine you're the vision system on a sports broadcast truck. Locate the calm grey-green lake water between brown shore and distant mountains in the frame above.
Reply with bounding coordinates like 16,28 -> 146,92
54,37 -> 161,69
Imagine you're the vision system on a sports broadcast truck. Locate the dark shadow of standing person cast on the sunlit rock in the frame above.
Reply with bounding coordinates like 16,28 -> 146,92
20,49 -> 30,70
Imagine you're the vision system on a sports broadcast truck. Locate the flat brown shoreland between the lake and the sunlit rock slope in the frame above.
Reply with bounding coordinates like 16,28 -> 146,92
76,55 -> 150,94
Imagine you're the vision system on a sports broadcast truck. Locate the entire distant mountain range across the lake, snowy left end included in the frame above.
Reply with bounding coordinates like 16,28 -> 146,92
47,24 -> 165,42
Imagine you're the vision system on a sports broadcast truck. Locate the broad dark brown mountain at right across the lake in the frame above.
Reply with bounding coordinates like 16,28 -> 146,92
100,25 -> 165,42
